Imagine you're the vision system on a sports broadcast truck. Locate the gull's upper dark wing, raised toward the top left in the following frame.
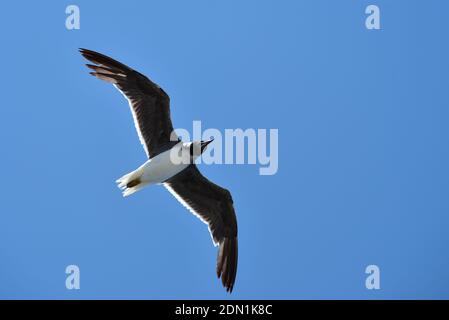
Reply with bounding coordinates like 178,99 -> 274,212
80,49 -> 177,157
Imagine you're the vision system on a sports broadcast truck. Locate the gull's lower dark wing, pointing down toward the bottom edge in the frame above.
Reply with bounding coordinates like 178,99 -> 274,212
164,164 -> 238,292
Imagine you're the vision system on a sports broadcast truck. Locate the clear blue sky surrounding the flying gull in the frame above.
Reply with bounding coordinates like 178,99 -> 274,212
0,0 -> 449,299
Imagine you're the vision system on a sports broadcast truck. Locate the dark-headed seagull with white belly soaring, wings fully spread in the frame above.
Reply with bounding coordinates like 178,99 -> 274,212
79,48 -> 238,293
